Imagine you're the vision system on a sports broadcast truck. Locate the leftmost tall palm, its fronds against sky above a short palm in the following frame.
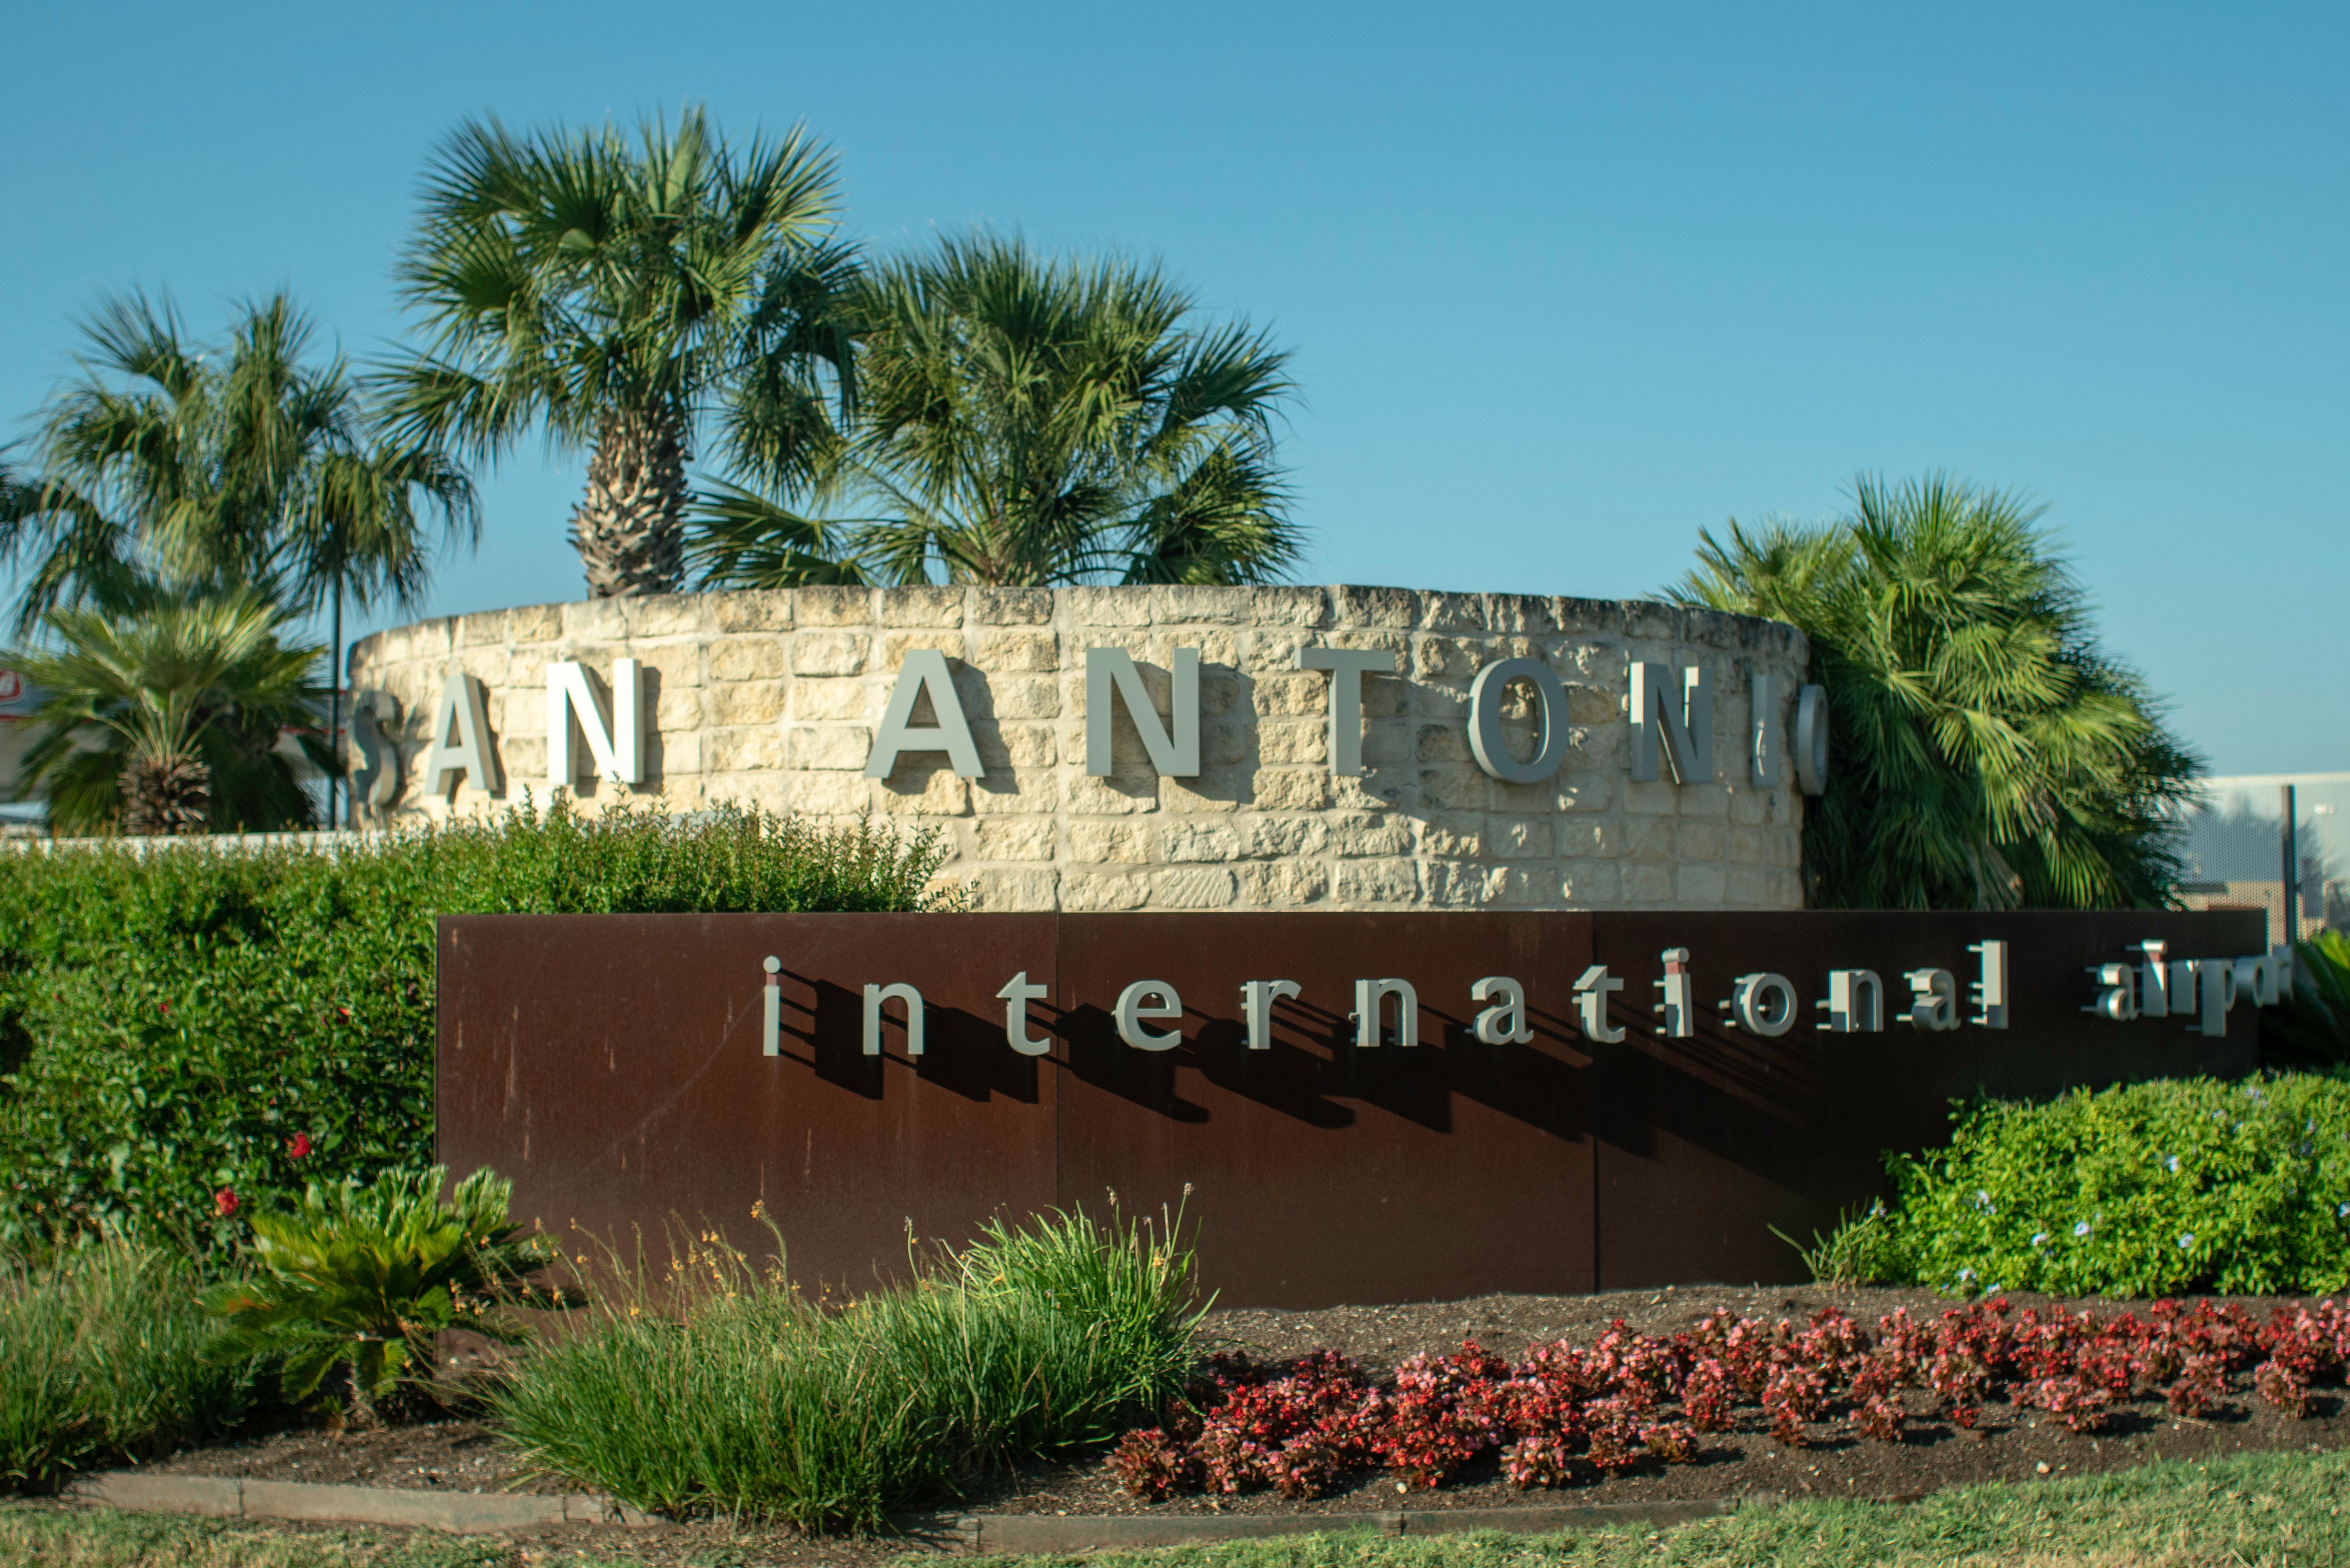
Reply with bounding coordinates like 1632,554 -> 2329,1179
0,294 -> 479,820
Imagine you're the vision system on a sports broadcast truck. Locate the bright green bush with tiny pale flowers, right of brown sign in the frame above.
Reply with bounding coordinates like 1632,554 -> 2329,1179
1821,1074 -> 2350,1295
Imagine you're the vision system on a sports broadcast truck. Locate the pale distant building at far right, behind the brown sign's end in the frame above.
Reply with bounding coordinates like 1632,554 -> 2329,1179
2181,774 -> 2350,943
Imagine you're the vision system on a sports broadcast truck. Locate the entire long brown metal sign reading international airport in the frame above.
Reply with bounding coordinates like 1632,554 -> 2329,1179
437,912 -> 2265,1307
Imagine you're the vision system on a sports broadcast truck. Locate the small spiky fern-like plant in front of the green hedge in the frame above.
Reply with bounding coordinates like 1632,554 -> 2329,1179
202,1166 -> 555,1422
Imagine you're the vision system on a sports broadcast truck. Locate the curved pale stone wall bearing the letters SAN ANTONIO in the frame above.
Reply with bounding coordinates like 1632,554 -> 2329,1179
350,588 -> 1807,910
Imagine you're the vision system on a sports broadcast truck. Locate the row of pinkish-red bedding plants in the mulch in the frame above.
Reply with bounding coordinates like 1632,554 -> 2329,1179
1109,1298 -> 2350,1500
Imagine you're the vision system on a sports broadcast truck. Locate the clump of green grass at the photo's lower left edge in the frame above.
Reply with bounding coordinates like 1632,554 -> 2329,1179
0,1236 -> 251,1488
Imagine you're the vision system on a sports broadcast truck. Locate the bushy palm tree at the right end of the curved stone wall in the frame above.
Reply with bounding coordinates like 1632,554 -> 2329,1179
1673,475 -> 2202,910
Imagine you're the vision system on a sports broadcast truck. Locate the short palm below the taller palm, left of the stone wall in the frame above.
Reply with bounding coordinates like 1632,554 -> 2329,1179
7,590 -> 324,834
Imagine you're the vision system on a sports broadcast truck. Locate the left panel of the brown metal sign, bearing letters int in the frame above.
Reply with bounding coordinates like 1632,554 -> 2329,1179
437,915 -> 1055,1288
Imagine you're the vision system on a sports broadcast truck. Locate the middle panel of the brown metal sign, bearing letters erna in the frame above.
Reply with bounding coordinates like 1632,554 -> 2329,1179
1058,915 -> 1591,1307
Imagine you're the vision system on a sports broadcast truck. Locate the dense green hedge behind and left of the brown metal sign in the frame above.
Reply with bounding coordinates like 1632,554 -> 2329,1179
0,797 -> 942,1251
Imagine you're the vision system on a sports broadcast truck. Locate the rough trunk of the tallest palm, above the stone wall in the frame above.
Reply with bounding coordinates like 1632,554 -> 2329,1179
571,409 -> 686,599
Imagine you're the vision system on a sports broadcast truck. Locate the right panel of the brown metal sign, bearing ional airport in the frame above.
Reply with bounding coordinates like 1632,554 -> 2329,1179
1593,910 -> 2265,1291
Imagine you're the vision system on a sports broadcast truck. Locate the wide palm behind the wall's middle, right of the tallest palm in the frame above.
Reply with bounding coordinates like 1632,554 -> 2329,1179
705,235 -> 1300,585
